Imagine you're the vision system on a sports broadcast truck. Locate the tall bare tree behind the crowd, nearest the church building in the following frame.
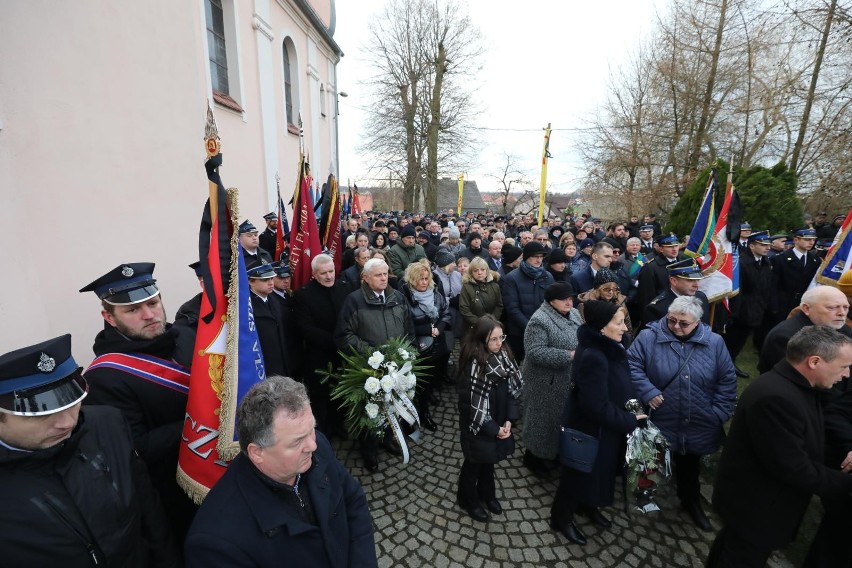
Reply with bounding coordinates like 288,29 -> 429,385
361,0 -> 482,211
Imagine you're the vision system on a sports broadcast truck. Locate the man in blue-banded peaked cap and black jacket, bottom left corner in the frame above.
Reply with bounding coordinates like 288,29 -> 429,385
0,334 -> 180,568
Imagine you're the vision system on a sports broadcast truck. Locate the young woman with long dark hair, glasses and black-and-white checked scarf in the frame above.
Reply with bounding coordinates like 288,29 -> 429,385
458,315 -> 522,522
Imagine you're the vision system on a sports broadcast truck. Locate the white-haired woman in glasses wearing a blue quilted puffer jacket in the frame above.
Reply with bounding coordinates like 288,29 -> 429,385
627,296 -> 737,531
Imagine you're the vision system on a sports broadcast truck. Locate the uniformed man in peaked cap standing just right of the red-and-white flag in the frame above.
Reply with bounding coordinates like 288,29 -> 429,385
725,231 -> 776,376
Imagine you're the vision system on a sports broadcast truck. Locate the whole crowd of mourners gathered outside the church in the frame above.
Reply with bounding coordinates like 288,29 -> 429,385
0,205 -> 852,567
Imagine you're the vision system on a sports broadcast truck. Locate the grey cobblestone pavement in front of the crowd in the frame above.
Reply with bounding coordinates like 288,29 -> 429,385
334,380 -> 792,568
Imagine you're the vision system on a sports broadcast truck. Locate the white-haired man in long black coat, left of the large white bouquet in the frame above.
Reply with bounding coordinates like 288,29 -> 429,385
293,254 -> 348,437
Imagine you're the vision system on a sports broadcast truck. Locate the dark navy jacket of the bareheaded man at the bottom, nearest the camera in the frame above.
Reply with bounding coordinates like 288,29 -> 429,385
184,432 -> 378,568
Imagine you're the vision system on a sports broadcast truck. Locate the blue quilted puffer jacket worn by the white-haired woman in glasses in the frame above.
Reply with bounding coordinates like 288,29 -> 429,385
627,318 -> 737,455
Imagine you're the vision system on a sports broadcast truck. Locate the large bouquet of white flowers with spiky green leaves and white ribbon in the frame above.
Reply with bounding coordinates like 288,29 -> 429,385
322,339 -> 426,463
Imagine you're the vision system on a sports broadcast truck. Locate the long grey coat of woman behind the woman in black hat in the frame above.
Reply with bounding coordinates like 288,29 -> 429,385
521,302 -> 583,459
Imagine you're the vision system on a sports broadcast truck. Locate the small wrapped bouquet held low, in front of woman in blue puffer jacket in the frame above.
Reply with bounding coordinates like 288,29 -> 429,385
624,399 -> 672,513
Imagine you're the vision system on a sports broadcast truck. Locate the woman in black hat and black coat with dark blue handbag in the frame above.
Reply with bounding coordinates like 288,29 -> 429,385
550,300 -> 646,544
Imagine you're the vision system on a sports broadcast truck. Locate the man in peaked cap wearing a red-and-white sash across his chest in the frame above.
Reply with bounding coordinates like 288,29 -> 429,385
80,262 -> 196,545
